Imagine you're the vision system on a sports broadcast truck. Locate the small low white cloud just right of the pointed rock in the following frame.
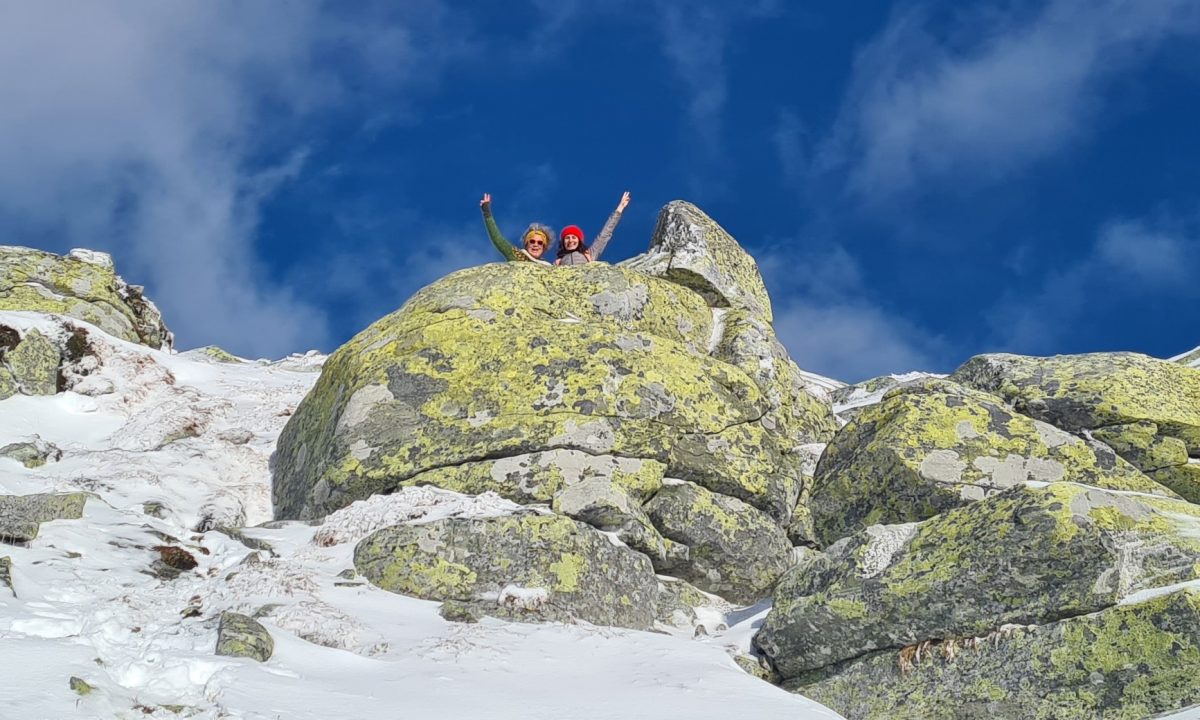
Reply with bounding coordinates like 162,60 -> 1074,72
758,245 -> 946,382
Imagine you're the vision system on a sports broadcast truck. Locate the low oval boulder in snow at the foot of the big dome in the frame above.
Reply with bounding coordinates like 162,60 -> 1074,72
354,512 -> 659,630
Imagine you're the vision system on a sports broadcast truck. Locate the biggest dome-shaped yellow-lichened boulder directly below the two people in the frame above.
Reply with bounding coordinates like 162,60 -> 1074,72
274,264 -> 798,517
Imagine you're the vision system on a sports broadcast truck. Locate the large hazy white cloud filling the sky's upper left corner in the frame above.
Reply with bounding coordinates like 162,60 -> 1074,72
0,0 -> 464,355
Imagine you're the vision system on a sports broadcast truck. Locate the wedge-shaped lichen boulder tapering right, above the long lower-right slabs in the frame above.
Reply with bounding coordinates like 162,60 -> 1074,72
809,379 -> 1175,544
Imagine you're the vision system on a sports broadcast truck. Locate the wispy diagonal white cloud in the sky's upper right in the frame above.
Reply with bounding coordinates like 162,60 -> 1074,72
816,0 -> 1200,198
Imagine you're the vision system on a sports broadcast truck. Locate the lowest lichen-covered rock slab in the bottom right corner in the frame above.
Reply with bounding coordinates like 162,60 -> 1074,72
784,588 -> 1200,720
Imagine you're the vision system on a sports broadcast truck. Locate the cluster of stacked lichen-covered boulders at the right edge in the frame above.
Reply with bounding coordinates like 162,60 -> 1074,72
755,353 -> 1200,720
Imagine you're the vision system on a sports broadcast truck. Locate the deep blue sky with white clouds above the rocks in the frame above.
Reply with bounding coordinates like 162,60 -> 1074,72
0,0 -> 1200,380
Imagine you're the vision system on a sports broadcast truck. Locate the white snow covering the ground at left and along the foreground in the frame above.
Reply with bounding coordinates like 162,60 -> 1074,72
0,312 -> 838,720
